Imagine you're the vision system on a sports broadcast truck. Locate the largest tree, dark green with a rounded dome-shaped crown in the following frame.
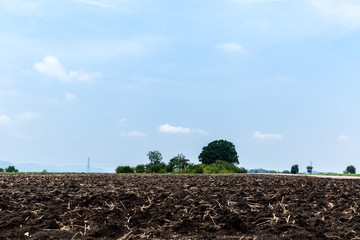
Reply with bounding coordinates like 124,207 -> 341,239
199,140 -> 239,164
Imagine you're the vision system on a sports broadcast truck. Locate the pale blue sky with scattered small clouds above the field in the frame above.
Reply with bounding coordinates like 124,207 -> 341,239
0,0 -> 360,172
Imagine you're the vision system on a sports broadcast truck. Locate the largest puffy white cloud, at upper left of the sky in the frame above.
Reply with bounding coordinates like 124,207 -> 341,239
34,55 -> 100,82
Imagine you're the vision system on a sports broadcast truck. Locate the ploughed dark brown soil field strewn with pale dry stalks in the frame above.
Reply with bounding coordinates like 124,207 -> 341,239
0,173 -> 360,240
